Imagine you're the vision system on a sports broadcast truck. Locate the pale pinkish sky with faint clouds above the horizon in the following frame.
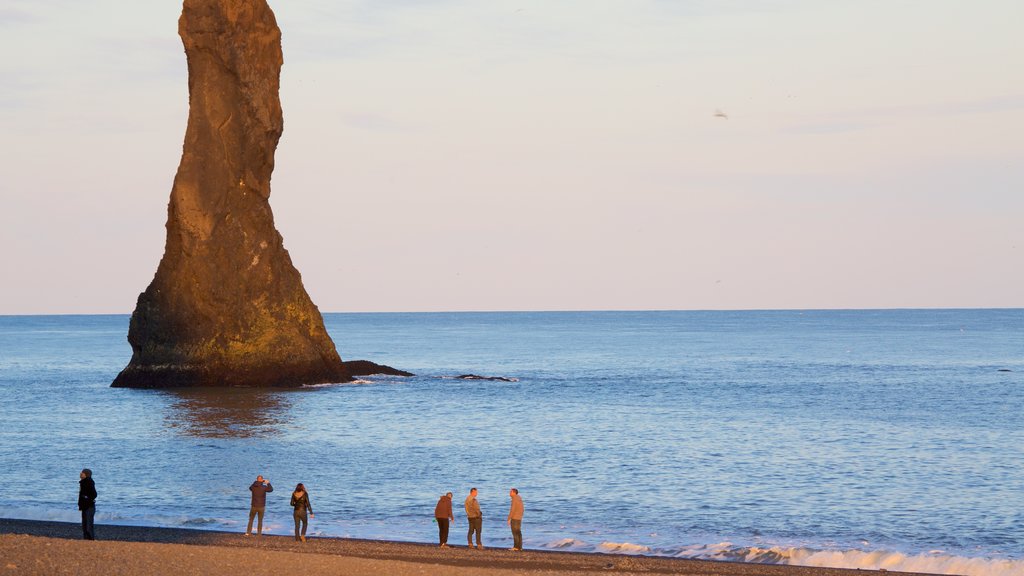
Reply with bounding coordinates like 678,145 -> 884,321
0,0 -> 1024,315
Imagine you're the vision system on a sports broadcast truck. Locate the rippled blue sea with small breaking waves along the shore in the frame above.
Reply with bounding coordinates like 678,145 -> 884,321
0,310 -> 1024,576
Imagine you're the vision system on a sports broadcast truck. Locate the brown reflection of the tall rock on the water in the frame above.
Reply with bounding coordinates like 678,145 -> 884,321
161,388 -> 292,438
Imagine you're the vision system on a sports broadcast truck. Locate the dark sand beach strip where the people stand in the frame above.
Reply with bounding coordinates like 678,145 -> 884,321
0,519 -> 942,576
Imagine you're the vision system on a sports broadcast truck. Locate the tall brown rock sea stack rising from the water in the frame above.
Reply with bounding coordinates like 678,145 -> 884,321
113,0 -> 351,387
